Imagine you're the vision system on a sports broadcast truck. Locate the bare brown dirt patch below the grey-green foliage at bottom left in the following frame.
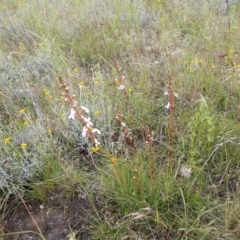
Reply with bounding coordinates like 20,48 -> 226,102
0,194 -> 91,240
